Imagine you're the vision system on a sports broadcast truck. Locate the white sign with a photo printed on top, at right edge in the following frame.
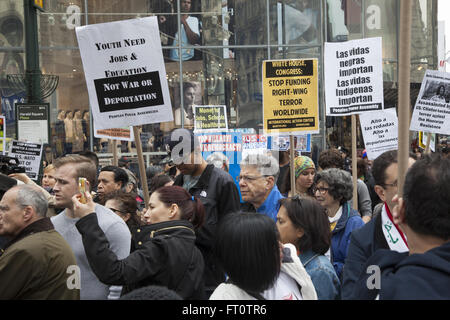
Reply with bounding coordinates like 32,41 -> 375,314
409,70 -> 450,135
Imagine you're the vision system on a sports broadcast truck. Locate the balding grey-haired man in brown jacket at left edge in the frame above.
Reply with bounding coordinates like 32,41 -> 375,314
0,185 -> 80,300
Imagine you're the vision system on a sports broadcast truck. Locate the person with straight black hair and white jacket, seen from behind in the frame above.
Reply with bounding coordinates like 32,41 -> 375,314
209,212 -> 317,300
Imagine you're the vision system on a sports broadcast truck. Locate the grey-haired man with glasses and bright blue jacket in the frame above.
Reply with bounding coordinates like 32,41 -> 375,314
238,154 -> 284,222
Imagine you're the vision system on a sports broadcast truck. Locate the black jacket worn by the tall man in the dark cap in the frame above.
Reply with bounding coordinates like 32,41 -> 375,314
174,164 -> 240,292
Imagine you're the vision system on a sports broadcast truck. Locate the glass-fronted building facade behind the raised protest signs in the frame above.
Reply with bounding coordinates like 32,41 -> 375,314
0,0 -> 438,166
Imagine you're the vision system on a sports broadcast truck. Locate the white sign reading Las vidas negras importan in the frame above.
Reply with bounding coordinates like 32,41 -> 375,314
324,38 -> 384,116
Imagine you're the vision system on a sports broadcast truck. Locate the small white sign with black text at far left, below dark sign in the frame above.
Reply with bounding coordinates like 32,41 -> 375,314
8,140 -> 42,180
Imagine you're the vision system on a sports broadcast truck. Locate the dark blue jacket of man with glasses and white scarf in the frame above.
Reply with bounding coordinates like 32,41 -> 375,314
341,206 -> 389,300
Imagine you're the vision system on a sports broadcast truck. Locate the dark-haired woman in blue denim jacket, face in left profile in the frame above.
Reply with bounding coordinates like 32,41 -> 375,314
277,196 -> 341,300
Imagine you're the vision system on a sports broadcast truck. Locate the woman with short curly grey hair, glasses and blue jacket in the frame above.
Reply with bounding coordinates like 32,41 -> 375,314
314,168 -> 364,279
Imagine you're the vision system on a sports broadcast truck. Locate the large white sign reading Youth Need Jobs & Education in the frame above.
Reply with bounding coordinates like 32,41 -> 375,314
76,17 -> 173,129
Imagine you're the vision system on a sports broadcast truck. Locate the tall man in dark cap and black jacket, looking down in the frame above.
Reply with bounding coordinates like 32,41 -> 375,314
167,129 -> 240,298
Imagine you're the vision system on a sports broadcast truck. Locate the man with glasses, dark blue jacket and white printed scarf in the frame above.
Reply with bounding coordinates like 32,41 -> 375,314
342,150 -> 415,299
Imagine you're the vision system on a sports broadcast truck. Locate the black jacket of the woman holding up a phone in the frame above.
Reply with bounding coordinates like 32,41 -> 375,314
76,213 -> 204,299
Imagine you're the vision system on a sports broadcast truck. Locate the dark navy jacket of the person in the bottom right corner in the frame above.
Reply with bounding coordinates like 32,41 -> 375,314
355,242 -> 450,300
